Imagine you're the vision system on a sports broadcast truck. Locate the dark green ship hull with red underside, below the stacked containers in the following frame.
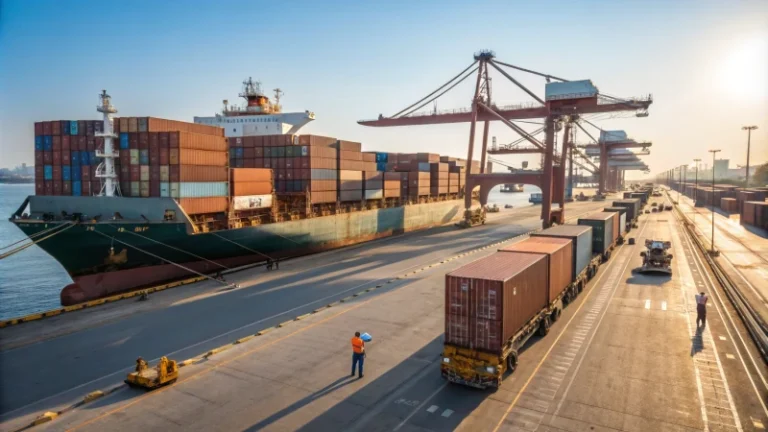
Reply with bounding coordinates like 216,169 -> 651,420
13,200 -> 463,306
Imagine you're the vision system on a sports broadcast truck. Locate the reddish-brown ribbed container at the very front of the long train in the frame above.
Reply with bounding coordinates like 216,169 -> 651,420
445,252 -> 549,354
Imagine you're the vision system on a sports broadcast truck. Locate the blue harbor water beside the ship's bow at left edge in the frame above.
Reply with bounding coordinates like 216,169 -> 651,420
0,183 -> 72,319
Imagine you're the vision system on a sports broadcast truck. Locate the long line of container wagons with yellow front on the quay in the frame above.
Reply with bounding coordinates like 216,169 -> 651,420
440,201 -> 642,388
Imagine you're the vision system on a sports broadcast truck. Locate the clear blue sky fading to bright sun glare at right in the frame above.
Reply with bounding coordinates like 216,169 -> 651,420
0,0 -> 768,178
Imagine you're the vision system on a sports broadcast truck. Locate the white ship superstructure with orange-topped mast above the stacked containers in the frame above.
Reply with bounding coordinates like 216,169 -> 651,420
194,78 -> 315,137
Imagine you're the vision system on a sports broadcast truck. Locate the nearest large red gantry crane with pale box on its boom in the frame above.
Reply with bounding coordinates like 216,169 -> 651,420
358,50 -> 653,227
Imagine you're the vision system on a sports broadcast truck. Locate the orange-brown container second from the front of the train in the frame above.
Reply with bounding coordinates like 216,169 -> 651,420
499,237 -> 573,303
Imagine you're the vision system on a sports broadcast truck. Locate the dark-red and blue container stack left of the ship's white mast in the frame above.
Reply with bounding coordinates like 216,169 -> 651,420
35,120 -> 104,196
